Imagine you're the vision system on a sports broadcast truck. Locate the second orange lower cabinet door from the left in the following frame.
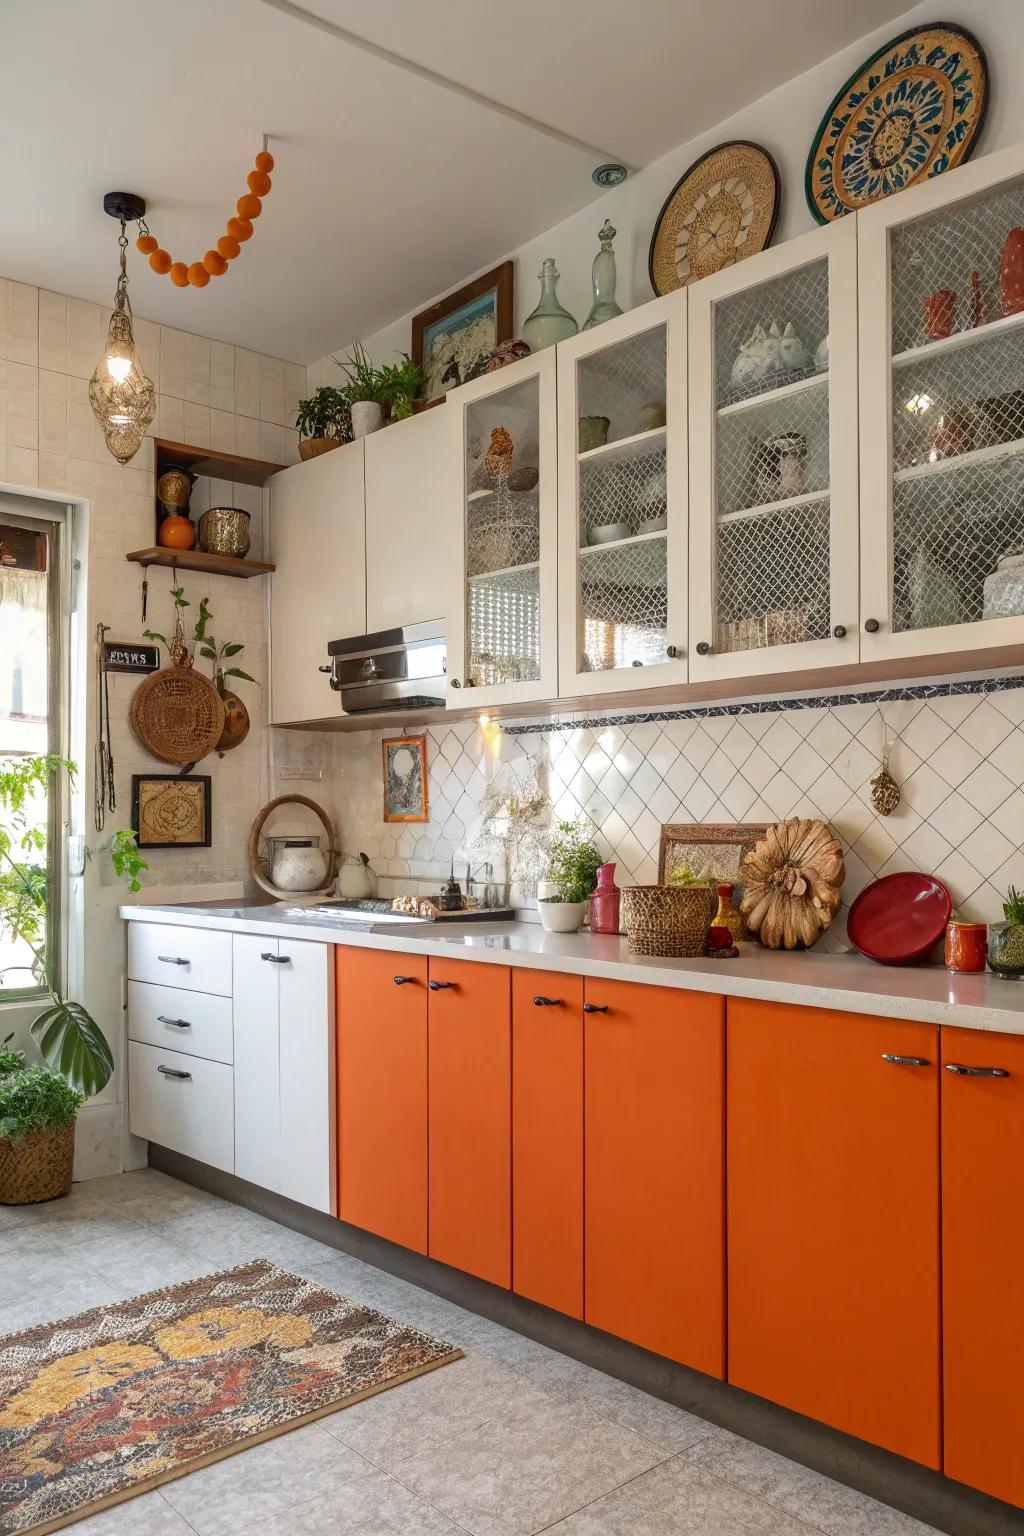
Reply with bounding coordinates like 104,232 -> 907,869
428,955 -> 511,1286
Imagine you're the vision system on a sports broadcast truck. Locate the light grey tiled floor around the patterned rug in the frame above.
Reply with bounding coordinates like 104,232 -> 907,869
0,1170 -> 930,1536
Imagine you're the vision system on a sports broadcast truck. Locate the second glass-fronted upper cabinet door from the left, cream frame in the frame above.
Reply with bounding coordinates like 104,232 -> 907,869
557,290 -> 686,697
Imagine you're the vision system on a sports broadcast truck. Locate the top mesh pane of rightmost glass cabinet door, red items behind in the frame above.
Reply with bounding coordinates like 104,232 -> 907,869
889,183 -> 1024,353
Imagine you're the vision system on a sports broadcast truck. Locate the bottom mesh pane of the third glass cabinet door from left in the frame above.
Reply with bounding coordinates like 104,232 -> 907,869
714,496 -> 831,651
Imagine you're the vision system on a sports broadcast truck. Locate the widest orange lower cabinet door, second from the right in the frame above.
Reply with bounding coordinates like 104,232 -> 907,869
726,998 -> 940,1467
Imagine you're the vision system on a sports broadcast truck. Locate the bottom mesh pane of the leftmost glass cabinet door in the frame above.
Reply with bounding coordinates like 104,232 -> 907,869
467,565 -> 540,688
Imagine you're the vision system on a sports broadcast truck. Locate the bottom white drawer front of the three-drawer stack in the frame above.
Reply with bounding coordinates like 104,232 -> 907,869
127,1040 -> 235,1174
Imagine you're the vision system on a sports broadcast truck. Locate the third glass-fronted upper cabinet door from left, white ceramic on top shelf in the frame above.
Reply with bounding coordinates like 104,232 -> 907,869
689,218 -> 858,682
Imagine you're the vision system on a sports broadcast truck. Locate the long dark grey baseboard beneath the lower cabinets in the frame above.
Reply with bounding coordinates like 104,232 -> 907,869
149,1144 -> 1024,1536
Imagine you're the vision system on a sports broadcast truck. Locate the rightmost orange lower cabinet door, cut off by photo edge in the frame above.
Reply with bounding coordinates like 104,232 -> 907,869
943,1029 -> 1024,1505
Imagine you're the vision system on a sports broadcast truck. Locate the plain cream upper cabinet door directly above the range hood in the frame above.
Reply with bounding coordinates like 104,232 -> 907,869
362,404 -> 459,634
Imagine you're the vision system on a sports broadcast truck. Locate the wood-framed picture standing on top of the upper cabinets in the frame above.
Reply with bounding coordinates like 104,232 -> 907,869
413,261 -> 513,404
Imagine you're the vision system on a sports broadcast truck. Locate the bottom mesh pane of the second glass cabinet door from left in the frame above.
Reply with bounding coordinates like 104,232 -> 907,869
579,535 -> 668,671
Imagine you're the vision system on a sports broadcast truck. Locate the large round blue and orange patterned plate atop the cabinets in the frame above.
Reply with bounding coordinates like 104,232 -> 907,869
804,22 -> 989,224
